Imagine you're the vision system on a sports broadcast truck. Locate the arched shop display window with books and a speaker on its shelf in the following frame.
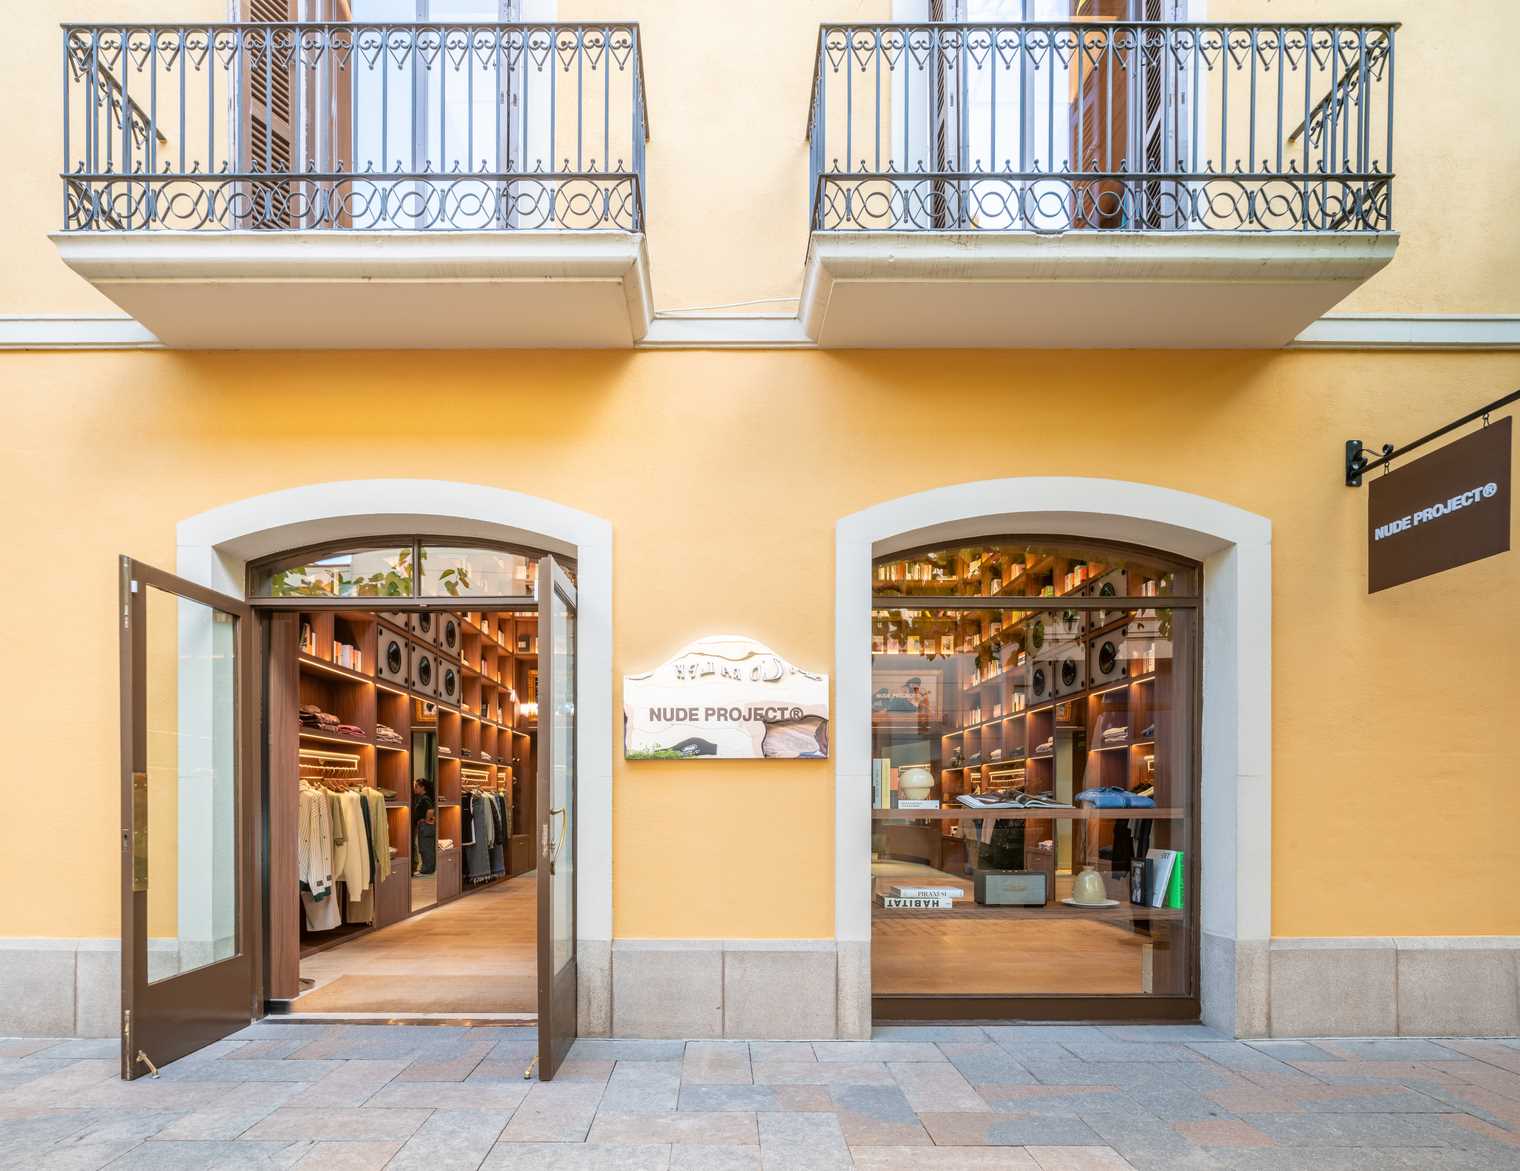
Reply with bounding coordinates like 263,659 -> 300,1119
871,543 -> 1198,1016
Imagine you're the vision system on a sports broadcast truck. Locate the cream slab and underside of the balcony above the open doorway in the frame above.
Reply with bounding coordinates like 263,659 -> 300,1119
52,230 -> 652,350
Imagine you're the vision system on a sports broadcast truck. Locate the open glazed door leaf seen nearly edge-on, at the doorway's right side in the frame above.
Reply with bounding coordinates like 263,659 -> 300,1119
538,557 -> 576,1081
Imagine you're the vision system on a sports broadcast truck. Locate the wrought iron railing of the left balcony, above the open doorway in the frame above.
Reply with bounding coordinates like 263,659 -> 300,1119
62,23 -> 649,231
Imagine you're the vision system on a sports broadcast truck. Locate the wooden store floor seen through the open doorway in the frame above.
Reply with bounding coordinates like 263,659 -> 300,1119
290,873 -> 538,1013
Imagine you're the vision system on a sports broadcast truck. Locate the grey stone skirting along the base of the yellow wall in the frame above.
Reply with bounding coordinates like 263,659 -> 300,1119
0,935 -> 1520,1040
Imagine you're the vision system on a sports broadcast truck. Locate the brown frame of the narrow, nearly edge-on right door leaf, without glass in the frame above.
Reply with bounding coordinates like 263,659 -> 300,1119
538,554 -> 579,1081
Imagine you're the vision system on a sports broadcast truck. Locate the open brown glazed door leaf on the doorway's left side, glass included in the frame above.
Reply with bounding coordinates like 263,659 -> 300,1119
120,557 -> 261,1080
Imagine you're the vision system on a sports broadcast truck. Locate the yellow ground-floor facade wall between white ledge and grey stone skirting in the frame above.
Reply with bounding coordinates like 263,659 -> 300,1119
0,343 -> 1520,938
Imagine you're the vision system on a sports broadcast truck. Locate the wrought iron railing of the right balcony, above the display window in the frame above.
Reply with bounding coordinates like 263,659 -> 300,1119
807,20 -> 1398,231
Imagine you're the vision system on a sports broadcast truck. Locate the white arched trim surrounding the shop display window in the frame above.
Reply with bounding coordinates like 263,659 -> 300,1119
834,476 -> 1272,1036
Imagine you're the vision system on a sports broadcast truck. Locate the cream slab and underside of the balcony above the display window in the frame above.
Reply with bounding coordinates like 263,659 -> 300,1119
801,231 -> 1398,350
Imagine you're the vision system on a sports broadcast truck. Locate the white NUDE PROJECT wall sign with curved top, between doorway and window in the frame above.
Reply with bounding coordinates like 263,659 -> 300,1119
623,634 -> 828,760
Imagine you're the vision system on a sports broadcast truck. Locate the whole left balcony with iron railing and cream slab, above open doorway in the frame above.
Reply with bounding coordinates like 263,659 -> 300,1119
52,23 -> 652,348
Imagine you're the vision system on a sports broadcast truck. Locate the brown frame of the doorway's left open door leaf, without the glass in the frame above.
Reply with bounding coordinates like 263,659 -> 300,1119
119,557 -> 263,1081
